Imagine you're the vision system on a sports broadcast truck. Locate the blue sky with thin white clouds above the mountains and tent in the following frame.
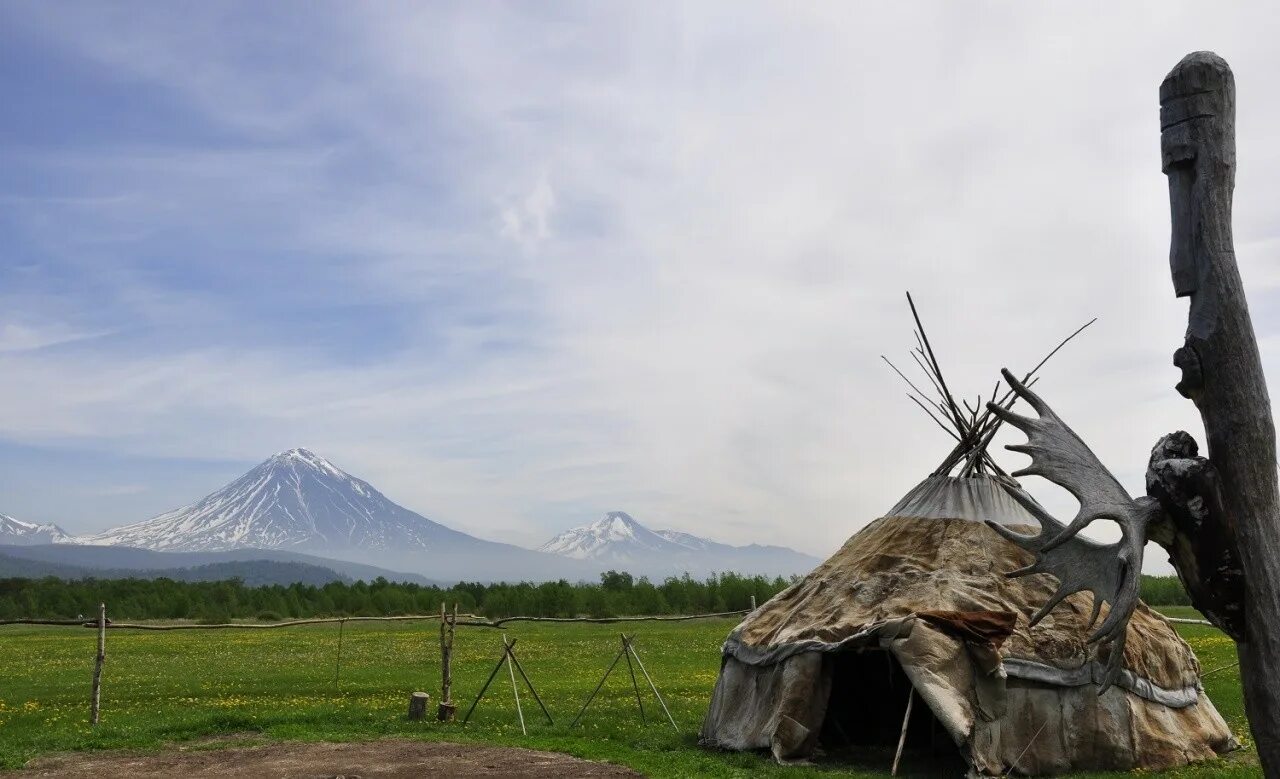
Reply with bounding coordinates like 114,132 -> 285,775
0,1 -> 1280,570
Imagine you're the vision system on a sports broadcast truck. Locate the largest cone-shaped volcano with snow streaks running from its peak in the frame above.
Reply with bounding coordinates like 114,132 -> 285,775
84,449 -> 479,554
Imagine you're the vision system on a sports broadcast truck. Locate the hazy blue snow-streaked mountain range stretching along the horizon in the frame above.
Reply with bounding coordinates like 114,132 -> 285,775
0,449 -> 818,583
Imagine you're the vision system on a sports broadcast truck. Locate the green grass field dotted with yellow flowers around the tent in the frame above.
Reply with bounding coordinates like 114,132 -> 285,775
0,609 -> 1258,776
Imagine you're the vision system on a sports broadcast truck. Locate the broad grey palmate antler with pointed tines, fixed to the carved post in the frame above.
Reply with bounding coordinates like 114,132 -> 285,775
987,370 -> 1161,693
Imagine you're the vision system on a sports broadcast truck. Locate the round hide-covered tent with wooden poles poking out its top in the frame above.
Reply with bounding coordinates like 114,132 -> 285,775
701,301 -> 1235,775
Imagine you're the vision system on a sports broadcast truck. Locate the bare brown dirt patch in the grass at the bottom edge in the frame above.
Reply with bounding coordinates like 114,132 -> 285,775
15,739 -> 641,779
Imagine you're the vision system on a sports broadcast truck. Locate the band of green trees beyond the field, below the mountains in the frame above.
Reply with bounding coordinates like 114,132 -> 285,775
0,570 -> 1190,623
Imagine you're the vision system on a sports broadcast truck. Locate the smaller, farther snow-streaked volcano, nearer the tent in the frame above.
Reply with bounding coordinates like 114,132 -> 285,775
538,512 -> 818,576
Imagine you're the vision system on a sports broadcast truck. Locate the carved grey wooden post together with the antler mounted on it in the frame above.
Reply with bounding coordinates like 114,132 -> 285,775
988,51 -> 1280,778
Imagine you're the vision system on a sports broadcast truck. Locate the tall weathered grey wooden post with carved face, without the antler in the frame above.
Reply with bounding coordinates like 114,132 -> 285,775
1160,51 -> 1280,776
